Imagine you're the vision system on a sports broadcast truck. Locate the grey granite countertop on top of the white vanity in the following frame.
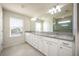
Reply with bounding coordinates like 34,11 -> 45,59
25,32 -> 74,41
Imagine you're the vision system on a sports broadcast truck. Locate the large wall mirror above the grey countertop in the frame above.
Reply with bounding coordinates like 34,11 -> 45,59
31,3 -> 73,33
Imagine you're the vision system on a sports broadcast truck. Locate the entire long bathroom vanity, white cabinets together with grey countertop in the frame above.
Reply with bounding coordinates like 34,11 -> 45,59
25,32 -> 74,56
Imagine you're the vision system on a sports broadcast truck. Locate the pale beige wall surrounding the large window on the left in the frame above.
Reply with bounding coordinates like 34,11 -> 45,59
3,10 -> 30,48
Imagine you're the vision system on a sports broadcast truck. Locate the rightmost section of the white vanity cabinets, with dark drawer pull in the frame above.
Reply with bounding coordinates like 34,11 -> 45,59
58,40 -> 73,56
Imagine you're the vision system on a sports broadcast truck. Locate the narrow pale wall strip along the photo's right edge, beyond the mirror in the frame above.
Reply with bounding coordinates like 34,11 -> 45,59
73,4 -> 79,56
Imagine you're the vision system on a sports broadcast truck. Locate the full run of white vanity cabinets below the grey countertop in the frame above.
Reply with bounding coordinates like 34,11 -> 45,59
26,33 -> 73,56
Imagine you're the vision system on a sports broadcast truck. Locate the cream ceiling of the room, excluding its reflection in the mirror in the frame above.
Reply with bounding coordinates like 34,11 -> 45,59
1,3 -> 56,17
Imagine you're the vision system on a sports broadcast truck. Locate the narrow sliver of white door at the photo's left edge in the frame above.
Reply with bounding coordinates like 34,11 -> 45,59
0,6 -> 3,52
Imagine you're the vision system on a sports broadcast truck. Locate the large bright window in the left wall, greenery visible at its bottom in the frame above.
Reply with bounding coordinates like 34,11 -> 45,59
10,17 -> 23,37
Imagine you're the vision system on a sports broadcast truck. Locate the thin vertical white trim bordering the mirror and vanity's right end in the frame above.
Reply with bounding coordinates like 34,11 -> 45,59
73,3 -> 78,55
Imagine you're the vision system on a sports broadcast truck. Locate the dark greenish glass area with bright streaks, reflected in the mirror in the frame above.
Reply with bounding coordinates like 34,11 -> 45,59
53,16 -> 72,33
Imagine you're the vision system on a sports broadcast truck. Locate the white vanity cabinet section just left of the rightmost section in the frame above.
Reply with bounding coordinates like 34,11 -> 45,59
42,37 -> 58,56
